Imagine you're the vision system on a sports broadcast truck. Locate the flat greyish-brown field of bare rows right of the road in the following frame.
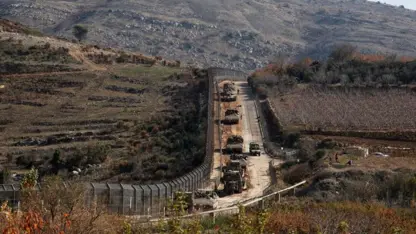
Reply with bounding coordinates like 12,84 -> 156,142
272,87 -> 416,131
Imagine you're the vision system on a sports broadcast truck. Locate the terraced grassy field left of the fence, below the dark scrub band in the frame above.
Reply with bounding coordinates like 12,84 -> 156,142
0,65 -> 207,182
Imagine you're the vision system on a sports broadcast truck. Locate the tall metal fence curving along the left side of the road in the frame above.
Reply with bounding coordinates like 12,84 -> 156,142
0,68 -> 246,217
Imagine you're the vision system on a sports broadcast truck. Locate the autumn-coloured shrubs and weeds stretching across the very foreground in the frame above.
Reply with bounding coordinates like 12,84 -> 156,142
0,177 -> 416,234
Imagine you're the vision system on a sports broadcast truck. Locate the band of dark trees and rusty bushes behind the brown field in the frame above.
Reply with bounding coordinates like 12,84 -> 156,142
252,45 -> 416,88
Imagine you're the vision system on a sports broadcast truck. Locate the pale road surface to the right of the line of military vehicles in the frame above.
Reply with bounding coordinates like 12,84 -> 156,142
214,81 -> 271,208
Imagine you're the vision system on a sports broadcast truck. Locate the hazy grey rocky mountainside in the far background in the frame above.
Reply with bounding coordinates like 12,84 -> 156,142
0,0 -> 416,70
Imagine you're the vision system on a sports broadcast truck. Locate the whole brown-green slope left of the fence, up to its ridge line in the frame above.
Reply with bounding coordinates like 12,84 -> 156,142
0,20 -> 207,183
